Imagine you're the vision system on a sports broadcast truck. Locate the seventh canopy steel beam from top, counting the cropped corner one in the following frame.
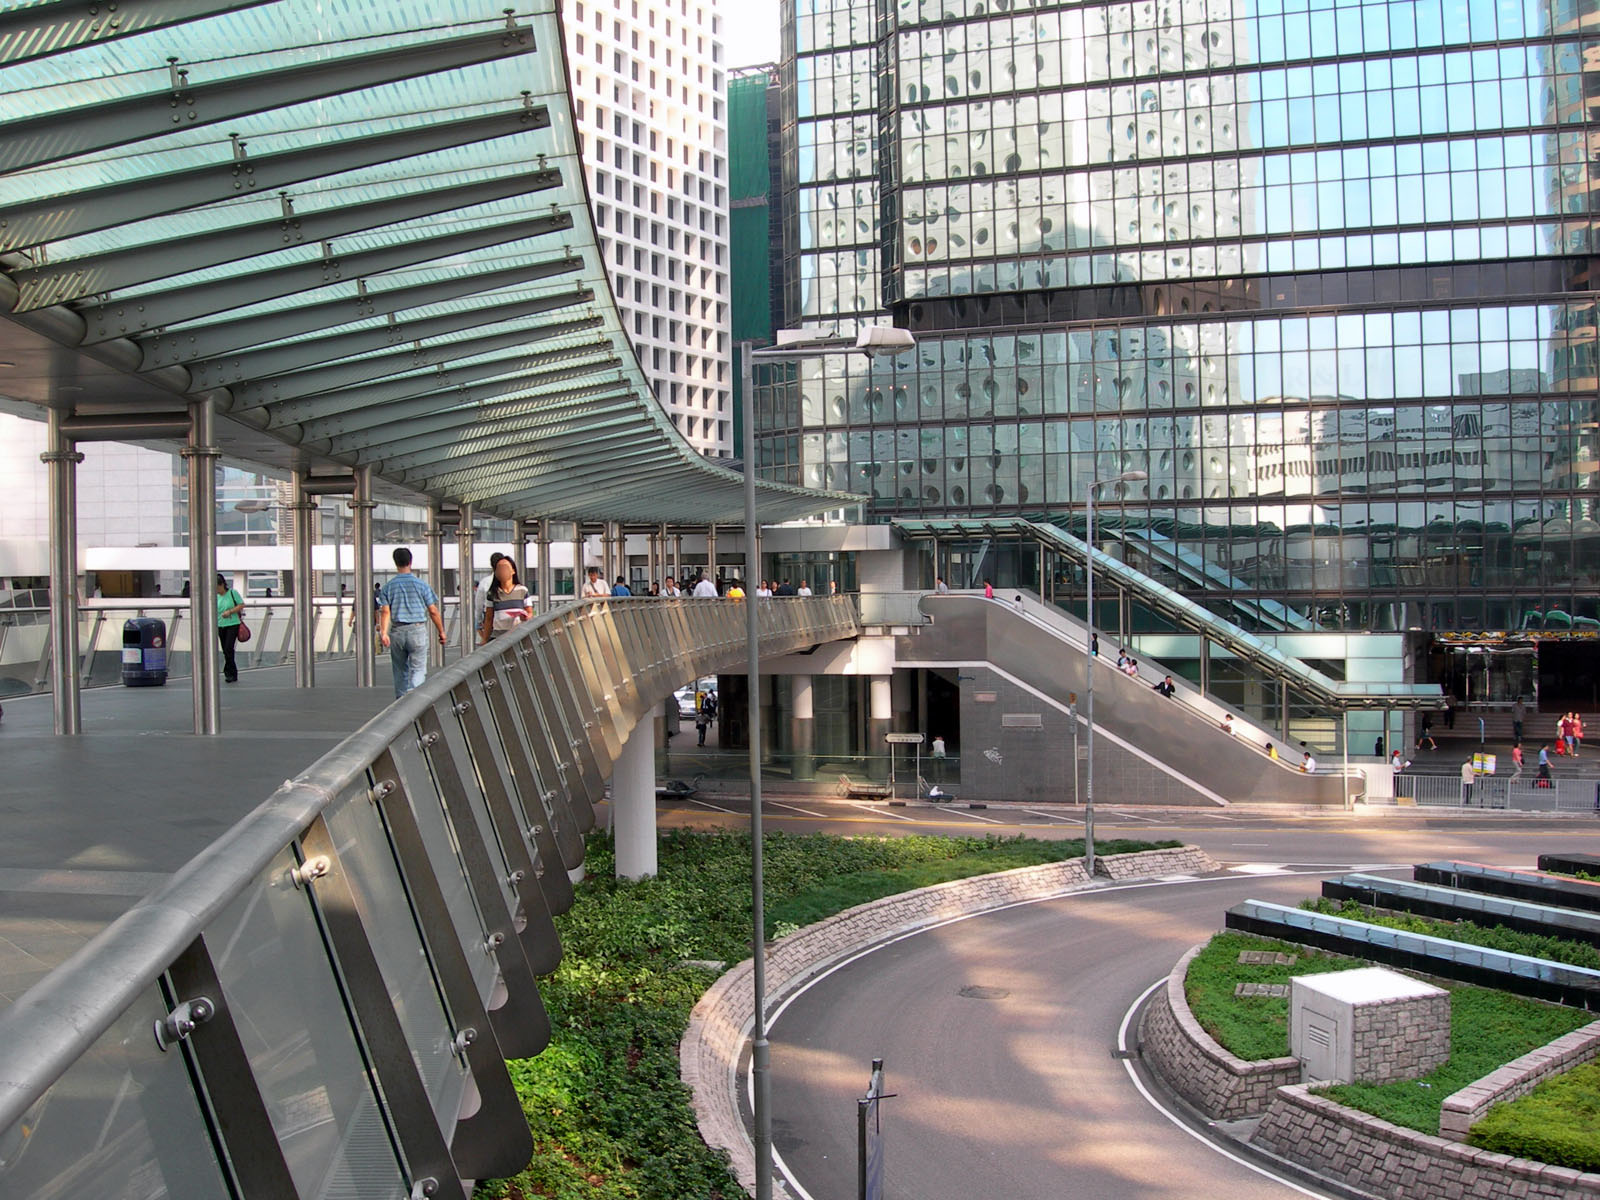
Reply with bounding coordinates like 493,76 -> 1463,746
189,288 -> 595,387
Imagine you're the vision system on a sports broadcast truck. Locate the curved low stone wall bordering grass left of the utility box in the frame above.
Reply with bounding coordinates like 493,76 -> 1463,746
1139,942 -> 1301,1122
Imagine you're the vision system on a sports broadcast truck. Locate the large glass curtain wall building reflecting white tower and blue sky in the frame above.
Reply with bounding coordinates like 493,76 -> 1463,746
758,0 -> 1600,652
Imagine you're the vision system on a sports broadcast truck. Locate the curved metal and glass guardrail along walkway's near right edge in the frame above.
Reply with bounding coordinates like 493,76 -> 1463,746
0,597 -> 858,1200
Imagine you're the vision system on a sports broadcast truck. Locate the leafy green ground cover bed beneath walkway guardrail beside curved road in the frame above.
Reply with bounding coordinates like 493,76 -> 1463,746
475,832 -> 1179,1200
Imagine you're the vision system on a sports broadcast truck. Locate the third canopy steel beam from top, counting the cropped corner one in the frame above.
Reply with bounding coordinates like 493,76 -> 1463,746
0,102 -> 550,251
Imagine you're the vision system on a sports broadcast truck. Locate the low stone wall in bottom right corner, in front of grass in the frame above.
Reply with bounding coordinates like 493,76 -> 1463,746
1250,1083 -> 1600,1200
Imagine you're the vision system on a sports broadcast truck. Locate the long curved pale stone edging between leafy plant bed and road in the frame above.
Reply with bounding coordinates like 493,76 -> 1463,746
678,846 -> 1219,1197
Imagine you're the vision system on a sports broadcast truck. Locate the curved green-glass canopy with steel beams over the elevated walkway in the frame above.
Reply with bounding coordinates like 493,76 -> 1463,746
0,0 -> 858,523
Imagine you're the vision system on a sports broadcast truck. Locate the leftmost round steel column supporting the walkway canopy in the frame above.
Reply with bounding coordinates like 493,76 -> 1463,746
38,408 -> 84,733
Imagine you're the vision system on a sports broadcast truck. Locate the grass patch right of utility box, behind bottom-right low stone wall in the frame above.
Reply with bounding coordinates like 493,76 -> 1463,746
1318,986 -> 1592,1134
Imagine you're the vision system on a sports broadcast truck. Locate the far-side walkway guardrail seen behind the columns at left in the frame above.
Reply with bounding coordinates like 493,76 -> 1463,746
0,597 -> 459,696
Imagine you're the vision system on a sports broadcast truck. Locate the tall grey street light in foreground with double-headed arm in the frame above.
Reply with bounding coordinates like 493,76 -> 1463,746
739,326 -> 917,1200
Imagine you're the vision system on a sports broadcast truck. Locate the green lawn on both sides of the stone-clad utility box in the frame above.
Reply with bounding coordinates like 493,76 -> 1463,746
1184,933 -> 1590,1134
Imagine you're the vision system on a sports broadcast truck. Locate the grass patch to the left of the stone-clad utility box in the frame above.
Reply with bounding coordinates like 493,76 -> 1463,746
1184,933 -> 1371,1061
